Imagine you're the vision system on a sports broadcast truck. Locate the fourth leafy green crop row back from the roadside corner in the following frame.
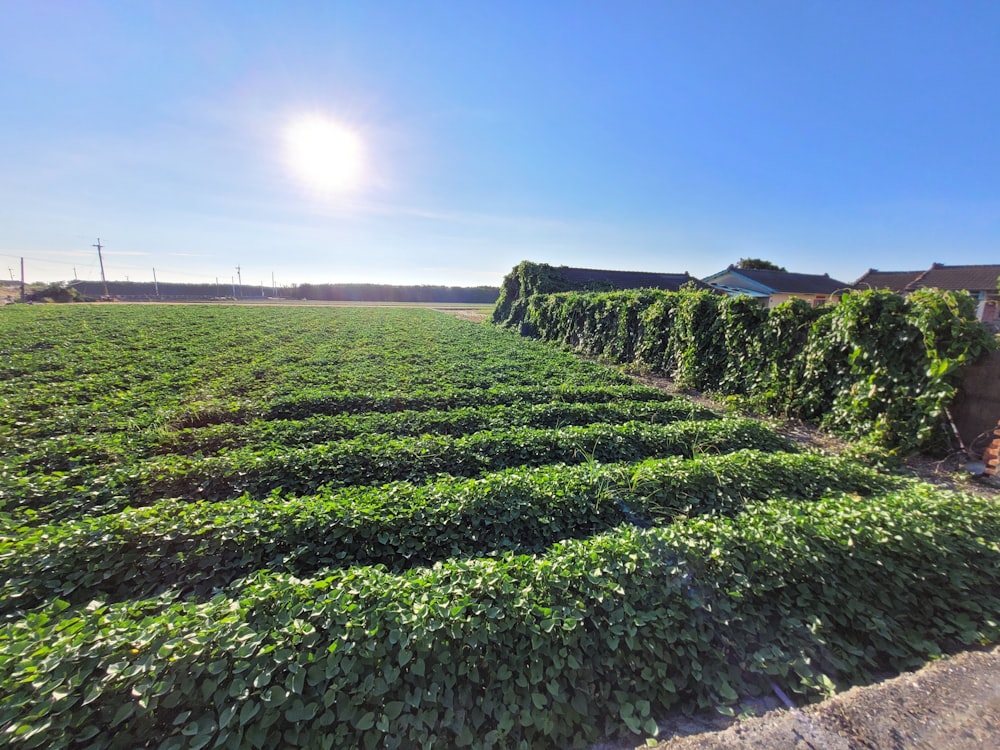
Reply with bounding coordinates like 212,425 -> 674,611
8,386 -> 700,472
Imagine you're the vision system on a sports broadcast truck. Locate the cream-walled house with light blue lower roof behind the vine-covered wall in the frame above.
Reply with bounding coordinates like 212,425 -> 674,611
702,266 -> 851,307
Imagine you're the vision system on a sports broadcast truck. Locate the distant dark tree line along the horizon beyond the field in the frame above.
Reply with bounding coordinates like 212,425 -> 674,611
60,281 -> 500,304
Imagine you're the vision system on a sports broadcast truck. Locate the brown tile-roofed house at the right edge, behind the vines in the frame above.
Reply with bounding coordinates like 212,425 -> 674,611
852,263 -> 1000,324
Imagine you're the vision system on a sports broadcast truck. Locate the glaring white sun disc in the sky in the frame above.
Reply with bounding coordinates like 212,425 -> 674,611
285,115 -> 364,193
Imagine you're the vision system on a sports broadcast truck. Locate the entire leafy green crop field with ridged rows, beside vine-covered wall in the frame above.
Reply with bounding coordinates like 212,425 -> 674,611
0,305 -> 1000,750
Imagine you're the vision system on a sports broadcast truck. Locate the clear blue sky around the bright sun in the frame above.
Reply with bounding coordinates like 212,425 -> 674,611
0,0 -> 1000,285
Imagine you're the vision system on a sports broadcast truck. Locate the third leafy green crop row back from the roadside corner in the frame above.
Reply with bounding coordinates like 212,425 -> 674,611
0,419 -> 792,526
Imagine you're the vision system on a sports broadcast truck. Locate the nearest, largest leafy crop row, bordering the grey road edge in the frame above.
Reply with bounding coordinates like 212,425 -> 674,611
0,487 -> 1000,750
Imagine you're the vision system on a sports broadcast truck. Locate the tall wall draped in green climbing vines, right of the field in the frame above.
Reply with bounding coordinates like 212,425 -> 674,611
494,287 -> 994,455
